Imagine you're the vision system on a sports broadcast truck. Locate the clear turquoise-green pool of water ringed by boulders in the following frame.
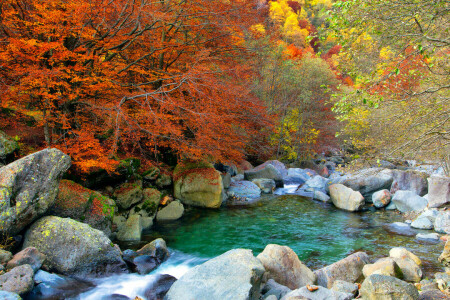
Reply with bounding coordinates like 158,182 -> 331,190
145,195 -> 443,271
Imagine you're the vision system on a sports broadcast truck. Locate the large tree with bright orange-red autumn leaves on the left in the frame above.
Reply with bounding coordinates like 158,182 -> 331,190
0,0 -> 269,172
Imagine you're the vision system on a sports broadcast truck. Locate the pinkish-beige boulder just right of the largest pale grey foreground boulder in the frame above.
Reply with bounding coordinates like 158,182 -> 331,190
257,244 -> 317,290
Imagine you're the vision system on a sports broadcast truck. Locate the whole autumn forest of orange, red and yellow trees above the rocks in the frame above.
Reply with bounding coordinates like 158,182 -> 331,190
0,0 -> 450,175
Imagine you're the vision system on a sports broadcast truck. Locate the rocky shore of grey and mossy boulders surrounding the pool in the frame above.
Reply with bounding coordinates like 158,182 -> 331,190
0,130 -> 450,300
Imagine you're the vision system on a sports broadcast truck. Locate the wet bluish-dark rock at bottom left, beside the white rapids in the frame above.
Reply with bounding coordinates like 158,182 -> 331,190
27,270 -> 93,300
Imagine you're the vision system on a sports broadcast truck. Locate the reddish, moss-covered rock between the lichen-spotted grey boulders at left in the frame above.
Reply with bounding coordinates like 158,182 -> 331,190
48,180 -> 116,235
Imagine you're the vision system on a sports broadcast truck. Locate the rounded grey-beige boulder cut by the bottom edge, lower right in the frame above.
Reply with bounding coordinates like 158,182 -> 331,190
359,274 -> 419,300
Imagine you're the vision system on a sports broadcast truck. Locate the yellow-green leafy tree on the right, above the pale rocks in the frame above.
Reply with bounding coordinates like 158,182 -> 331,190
331,0 -> 450,172
